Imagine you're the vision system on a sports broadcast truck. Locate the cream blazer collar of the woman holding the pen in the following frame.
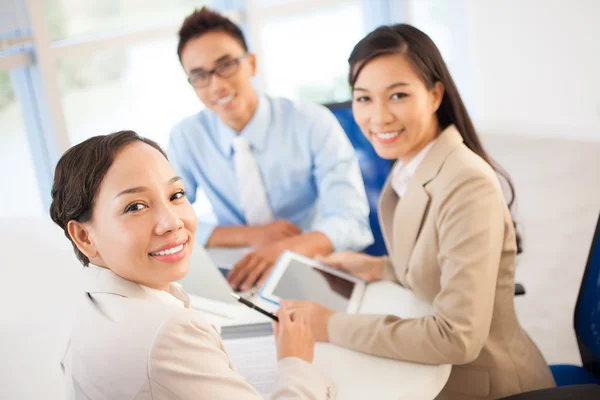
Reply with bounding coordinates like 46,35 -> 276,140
83,264 -> 190,308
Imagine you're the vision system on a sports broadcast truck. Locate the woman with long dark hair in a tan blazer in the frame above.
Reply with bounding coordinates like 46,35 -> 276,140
282,24 -> 554,399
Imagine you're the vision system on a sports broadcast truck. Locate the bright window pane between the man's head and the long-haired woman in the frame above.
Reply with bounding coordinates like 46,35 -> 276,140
259,1 -> 364,103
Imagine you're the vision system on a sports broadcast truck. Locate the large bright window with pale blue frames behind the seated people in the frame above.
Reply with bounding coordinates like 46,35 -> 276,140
0,0 -> 396,215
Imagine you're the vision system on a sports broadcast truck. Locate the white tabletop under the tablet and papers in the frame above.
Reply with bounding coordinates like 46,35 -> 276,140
192,248 -> 451,400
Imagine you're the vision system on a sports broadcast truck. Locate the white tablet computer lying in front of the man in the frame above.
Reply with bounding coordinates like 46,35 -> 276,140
259,251 -> 366,314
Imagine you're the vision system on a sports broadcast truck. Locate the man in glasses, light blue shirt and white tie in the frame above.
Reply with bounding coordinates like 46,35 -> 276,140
169,8 -> 373,290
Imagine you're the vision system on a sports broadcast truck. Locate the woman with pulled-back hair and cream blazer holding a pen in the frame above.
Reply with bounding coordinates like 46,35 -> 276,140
50,131 -> 336,400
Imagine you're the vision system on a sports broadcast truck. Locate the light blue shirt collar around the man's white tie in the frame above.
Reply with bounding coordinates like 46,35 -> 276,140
217,94 -> 271,156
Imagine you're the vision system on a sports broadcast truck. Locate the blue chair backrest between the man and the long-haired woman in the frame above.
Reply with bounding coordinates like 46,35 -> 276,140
325,102 -> 392,256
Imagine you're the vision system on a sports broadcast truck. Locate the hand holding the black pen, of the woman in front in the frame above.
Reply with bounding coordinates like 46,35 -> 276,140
273,307 -> 315,363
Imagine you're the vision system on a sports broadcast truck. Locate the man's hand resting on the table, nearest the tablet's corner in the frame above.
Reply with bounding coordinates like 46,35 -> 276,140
227,241 -> 285,291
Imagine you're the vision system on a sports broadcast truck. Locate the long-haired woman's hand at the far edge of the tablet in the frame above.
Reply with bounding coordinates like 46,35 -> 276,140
316,251 -> 385,282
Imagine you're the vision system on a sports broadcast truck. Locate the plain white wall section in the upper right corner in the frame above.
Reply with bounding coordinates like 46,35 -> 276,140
465,0 -> 600,141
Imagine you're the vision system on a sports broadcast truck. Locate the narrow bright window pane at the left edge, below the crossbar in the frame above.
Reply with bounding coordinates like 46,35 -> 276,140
0,71 -> 46,218
